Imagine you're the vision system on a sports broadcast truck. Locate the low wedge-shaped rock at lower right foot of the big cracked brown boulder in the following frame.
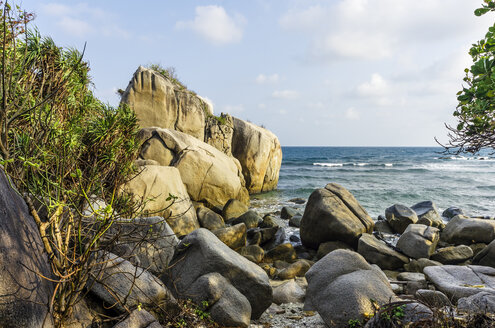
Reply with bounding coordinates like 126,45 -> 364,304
358,233 -> 409,270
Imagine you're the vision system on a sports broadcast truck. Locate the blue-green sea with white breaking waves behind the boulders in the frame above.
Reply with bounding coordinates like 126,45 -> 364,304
251,147 -> 495,219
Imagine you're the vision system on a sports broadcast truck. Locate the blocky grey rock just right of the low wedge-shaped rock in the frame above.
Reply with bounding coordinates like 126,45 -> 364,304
397,224 -> 440,259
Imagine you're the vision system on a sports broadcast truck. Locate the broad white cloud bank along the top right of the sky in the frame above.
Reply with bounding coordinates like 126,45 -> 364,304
279,0 -> 492,61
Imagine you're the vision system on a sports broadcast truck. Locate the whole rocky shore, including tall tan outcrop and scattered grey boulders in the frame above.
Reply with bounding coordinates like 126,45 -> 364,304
0,67 -> 495,328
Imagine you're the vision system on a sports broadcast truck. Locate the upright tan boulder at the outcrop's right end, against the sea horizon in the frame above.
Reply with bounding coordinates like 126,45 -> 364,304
232,117 -> 282,193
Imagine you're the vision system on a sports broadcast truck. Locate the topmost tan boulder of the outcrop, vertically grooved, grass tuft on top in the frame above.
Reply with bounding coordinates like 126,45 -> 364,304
122,66 -> 211,141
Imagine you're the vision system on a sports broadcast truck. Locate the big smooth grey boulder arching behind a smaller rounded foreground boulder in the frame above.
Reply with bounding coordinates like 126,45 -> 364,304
168,228 -> 272,319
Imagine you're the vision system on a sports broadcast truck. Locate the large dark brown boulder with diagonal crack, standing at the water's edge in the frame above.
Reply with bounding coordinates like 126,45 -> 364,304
300,183 -> 373,249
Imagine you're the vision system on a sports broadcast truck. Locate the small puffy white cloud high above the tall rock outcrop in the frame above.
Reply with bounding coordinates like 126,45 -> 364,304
175,5 -> 246,45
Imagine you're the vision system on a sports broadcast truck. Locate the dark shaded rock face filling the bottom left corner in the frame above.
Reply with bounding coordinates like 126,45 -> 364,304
0,170 -> 53,328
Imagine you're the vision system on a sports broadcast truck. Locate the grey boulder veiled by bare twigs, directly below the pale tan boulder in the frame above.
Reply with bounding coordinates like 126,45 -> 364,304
108,216 -> 179,275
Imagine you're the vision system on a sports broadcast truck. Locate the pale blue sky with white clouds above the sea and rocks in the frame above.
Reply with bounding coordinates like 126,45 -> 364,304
17,0 -> 495,146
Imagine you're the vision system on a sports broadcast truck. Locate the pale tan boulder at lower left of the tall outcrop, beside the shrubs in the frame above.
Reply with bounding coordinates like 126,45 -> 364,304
124,165 -> 199,236
